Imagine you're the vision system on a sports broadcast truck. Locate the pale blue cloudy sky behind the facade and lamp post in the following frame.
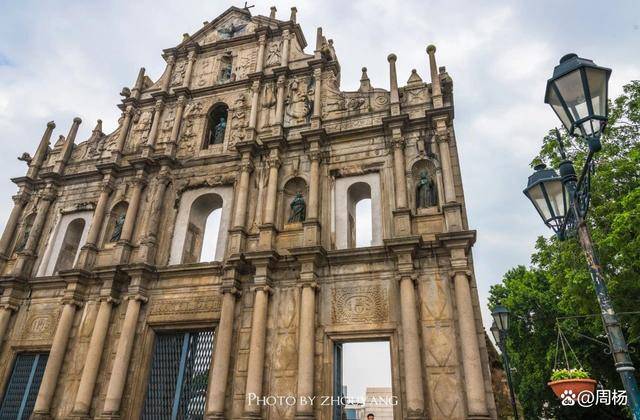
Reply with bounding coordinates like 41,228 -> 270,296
0,0 -> 640,380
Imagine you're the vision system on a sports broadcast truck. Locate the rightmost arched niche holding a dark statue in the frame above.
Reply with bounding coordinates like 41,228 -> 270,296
408,159 -> 442,213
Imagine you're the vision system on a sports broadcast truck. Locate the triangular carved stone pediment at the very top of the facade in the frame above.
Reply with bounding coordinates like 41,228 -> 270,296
180,7 -> 258,46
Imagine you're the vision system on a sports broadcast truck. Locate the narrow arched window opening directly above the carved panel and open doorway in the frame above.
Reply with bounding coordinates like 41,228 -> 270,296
347,182 -> 373,248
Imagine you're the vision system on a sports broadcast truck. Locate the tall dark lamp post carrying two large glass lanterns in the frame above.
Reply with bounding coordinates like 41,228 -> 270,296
523,54 -> 640,420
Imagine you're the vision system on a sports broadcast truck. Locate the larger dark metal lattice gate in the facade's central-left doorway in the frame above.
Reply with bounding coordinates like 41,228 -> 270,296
142,330 -> 213,420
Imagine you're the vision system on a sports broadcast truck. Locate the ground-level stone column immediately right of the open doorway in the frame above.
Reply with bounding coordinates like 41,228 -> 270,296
400,275 -> 424,419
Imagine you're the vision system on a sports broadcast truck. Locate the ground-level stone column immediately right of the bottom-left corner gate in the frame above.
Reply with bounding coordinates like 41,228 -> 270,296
31,300 -> 80,419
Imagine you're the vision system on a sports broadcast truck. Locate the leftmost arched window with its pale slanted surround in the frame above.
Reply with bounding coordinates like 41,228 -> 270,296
37,211 -> 93,276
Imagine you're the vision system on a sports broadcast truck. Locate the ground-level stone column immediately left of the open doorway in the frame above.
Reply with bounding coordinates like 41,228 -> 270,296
296,282 -> 316,419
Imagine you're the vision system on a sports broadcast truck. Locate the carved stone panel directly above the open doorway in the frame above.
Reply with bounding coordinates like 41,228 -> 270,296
331,286 -> 389,324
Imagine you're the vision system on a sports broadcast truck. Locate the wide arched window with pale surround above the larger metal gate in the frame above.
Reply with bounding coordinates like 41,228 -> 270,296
169,187 -> 233,265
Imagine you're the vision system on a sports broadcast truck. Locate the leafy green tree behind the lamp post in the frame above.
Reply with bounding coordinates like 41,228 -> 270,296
489,81 -> 640,419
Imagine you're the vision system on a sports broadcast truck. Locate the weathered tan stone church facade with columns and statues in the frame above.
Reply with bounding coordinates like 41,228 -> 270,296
0,7 -> 496,420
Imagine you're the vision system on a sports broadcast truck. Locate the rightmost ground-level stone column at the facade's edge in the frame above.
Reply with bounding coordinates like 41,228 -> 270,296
453,271 -> 488,416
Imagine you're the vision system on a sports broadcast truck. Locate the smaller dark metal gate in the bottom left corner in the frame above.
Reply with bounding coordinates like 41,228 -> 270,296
0,353 -> 49,420
